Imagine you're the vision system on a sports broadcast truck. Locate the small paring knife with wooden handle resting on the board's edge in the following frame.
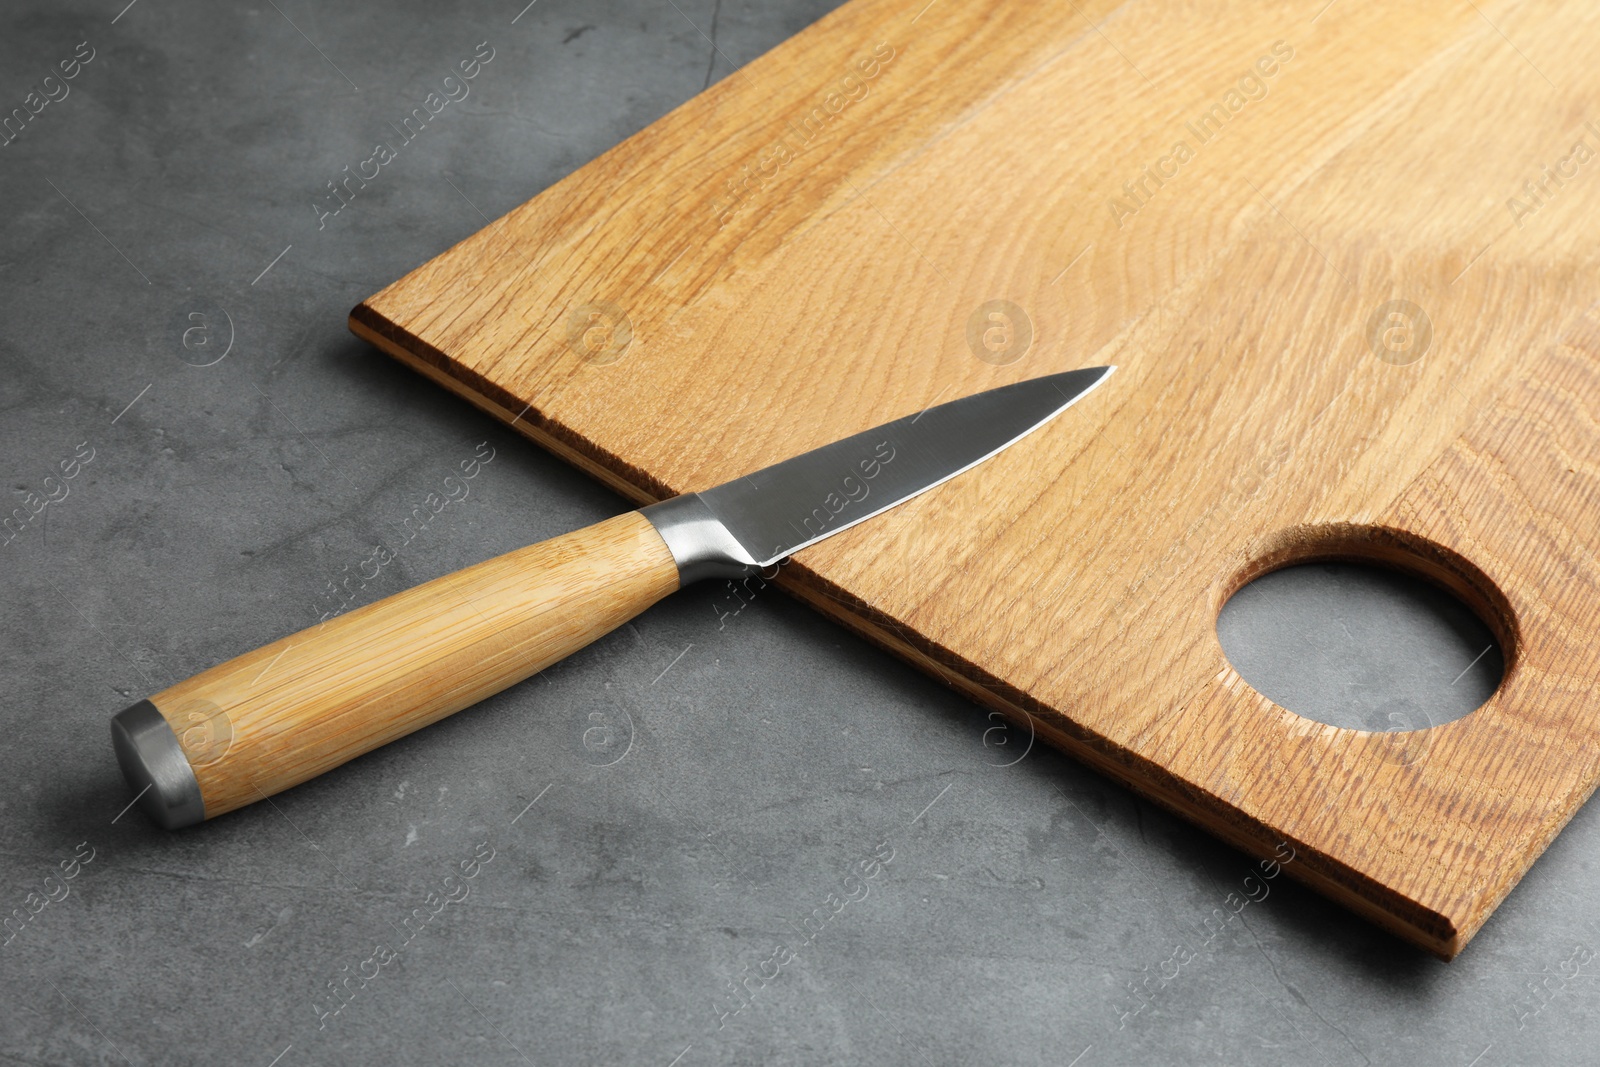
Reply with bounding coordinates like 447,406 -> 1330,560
110,366 -> 1115,830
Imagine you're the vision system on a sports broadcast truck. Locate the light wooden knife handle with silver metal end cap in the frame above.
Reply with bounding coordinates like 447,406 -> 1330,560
112,512 -> 678,829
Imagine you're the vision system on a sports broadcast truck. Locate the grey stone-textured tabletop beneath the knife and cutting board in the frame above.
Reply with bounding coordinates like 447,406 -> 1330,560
0,0 -> 1600,1067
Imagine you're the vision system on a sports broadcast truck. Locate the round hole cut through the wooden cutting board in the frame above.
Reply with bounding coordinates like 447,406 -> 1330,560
1216,525 -> 1515,739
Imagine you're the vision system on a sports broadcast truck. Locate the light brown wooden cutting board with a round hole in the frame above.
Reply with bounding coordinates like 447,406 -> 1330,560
350,0 -> 1600,958
